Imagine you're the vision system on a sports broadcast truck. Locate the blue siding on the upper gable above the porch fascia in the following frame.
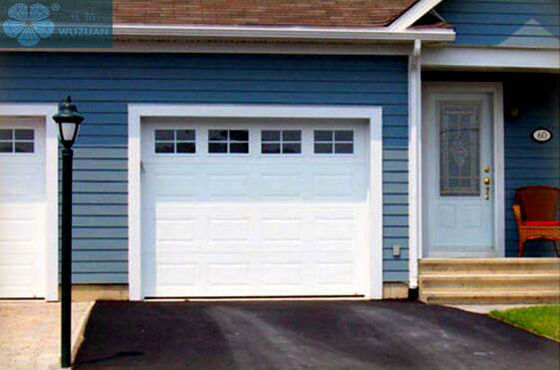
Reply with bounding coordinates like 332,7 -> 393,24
436,0 -> 560,48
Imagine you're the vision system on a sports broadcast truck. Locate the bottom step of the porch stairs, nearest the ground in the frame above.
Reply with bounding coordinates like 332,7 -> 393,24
420,290 -> 560,304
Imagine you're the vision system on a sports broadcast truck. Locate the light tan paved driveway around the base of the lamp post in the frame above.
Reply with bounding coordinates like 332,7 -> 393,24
0,300 -> 95,369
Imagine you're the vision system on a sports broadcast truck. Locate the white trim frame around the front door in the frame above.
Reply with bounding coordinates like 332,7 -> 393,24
417,82 -> 505,257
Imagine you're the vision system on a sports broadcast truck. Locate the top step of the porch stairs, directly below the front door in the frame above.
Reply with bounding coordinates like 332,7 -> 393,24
419,258 -> 560,275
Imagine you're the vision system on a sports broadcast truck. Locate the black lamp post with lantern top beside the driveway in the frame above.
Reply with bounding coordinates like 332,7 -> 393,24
53,96 -> 84,367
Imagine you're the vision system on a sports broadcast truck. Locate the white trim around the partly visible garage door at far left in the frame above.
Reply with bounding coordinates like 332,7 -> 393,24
0,103 -> 58,301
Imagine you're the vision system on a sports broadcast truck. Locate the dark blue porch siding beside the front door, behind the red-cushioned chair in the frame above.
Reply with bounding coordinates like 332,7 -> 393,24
423,72 -> 560,257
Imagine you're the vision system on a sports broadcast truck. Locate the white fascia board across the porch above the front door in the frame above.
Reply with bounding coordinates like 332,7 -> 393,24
422,47 -> 560,72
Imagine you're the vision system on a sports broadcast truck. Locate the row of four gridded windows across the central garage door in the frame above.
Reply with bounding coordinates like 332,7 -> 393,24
154,129 -> 354,154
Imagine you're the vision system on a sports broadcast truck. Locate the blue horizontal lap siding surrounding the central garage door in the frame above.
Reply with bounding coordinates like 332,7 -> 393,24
0,53 -> 408,283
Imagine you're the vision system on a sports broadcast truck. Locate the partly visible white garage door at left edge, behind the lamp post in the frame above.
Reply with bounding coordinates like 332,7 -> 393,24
0,118 -> 46,298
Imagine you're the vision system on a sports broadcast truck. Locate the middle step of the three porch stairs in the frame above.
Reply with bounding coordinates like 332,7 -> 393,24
419,273 -> 560,292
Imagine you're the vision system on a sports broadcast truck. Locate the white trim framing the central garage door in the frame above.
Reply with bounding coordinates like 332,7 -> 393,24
128,104 -> 383,300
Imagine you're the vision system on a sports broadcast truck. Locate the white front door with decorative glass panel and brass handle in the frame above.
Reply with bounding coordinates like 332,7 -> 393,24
423,93 -> 496,257
